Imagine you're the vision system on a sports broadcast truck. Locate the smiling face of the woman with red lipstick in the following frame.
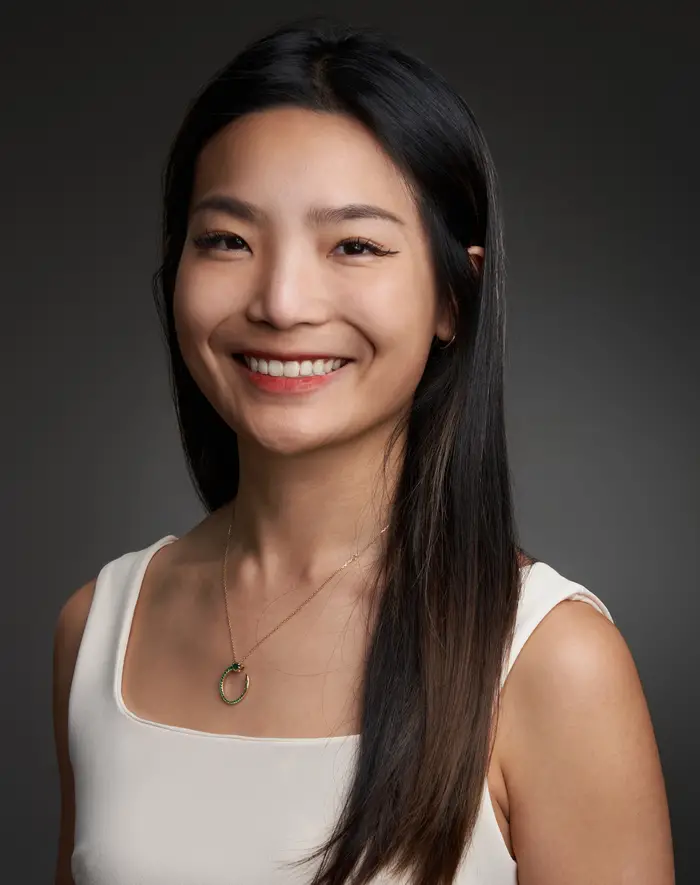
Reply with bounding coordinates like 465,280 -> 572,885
174,108 -> 451,454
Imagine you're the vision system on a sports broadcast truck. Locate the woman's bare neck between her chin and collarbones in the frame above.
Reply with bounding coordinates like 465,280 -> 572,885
231,424 -> 401,582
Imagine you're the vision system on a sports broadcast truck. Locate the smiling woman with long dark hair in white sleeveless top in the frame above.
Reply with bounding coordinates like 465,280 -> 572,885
55,15 -> 673,885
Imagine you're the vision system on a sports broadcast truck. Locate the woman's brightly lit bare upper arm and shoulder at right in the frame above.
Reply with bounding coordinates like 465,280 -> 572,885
499,600 -> 674,885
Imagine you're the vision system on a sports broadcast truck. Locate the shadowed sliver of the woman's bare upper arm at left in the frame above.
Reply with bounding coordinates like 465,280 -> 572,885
53,580 -> 95,885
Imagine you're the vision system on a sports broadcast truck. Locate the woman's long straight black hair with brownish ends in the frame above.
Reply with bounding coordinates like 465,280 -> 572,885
154,18 -> 522,885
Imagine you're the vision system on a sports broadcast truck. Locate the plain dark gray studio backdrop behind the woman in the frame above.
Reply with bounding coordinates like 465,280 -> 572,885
0,0 -> 700,883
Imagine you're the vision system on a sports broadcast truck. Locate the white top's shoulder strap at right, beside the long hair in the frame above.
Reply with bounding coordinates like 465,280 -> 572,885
501,560 -> 613,687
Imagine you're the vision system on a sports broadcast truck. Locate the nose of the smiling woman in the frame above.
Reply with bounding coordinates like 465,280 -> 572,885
247,247 -> 331,331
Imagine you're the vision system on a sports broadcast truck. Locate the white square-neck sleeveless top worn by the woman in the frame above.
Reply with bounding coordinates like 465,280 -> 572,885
68,535 -> 612,885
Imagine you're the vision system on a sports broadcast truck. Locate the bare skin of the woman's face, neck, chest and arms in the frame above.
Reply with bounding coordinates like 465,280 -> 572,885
54,108 -> 673,885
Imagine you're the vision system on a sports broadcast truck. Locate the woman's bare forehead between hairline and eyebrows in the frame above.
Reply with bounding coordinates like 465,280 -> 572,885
194,107 -> 415,221
